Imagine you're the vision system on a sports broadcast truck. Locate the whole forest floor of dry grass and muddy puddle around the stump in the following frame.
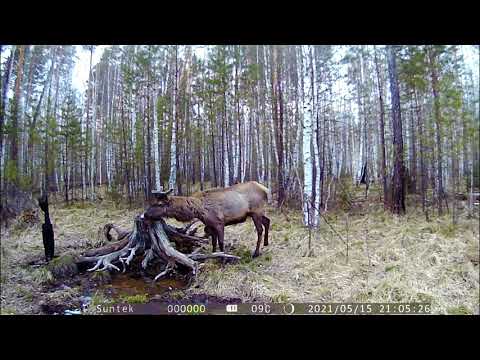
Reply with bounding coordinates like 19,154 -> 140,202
1,187 -> 480,314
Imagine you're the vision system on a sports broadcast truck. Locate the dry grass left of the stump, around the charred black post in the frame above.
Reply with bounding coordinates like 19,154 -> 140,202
0,201 -> 142,314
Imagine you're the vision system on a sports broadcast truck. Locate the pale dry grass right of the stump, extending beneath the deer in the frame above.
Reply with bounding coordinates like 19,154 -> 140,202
189,197 -> 479,314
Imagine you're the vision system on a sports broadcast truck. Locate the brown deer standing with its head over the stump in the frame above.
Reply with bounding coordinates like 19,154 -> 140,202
144,181 -> 271,258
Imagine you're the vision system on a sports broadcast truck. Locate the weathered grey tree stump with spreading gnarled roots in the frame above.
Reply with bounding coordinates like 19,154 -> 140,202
77,215 -> 239,280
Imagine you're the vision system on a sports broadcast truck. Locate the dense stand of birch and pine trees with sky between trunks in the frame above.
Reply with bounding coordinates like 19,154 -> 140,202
0,45 -> 479,225
